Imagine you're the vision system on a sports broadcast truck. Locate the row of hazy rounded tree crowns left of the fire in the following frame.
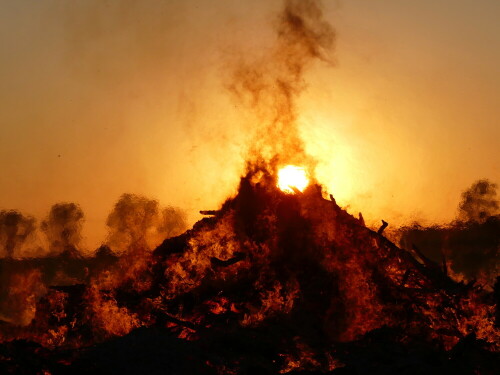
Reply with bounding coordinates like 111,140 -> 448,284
0,194 -> 187,259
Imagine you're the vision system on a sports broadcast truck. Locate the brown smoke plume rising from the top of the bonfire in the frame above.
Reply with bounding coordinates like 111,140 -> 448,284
228,0 -> 335,170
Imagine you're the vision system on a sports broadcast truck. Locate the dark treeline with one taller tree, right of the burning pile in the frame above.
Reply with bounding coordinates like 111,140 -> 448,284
399,179 -> 500,285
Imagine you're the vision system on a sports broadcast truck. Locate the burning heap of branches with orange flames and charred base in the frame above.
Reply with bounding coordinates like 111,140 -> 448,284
0,169 -> 499,374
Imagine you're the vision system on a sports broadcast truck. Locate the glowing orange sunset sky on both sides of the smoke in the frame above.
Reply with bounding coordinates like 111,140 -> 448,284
0,0 -> 500,251
